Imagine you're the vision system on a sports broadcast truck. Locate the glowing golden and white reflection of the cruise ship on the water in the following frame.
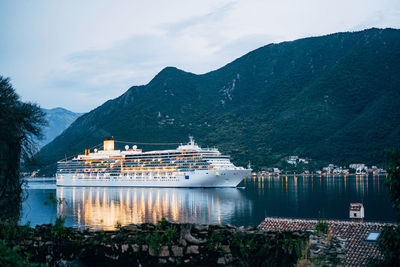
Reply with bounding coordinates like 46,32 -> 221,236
57,187 -> 252,230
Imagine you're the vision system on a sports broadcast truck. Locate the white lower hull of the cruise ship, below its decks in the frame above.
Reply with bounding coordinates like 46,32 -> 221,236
57,169 -> 251,187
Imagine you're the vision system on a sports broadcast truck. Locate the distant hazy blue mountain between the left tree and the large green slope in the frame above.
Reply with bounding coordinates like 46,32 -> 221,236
38,108 -> 83,147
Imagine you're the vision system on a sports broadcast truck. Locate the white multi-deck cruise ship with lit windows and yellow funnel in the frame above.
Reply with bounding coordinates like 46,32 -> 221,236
56,136 -> 251,187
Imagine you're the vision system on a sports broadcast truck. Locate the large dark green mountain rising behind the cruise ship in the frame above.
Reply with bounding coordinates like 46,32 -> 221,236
40,28 -> 400,172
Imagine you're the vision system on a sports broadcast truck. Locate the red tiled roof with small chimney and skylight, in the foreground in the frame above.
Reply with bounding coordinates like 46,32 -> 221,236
259,218 -> 390,266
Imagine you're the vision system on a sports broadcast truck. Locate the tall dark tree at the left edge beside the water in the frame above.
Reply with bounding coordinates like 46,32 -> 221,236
0,76 -> 46,222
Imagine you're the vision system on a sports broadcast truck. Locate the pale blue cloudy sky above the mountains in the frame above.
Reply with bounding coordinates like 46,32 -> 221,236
0,0 -> 400,112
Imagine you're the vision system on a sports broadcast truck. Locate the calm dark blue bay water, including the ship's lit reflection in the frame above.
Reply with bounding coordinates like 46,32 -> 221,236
21,176 -> 396,229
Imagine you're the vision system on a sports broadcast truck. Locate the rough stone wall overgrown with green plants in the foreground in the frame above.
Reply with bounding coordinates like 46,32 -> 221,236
0,221 -> 309,266
